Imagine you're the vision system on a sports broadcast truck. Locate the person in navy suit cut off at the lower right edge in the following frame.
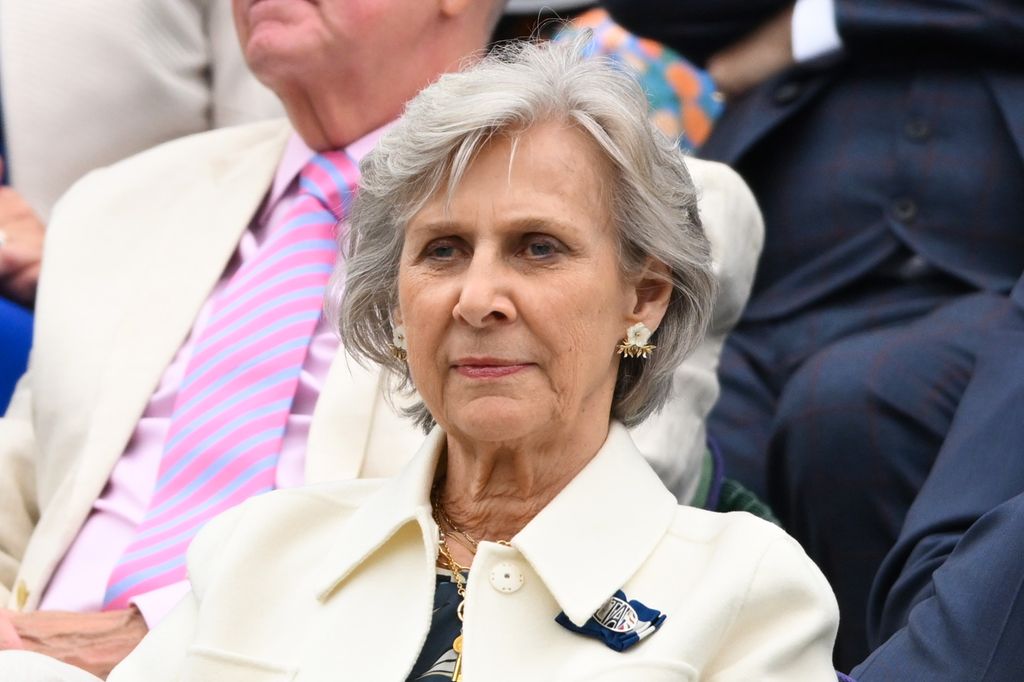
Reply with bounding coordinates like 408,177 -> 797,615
854,279 -> 1024,682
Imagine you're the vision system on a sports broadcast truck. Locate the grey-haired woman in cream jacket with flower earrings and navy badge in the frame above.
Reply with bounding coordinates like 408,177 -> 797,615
12,34 -> 838,682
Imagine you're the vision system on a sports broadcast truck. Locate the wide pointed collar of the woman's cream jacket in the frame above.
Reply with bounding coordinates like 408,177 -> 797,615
315,422 -> 677,626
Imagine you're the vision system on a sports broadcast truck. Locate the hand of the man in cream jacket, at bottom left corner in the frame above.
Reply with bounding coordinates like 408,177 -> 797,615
0,606 -> 148,678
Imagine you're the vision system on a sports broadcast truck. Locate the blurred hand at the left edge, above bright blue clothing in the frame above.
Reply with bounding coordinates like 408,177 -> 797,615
0,159 -> 45,306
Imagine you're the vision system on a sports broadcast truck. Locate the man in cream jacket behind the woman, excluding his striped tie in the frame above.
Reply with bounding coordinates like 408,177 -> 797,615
0,0 -> 761,672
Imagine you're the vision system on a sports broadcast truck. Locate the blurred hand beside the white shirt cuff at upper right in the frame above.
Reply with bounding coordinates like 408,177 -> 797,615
708,5 -> 795,99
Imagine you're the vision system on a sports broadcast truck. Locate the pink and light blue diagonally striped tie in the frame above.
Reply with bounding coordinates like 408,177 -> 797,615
103,152 -> 358,609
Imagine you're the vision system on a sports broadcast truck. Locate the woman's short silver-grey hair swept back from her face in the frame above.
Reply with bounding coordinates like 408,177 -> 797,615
328,32 -> 716,428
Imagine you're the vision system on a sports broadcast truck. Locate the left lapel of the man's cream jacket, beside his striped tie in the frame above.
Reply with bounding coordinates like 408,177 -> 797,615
22,123 -> 291,607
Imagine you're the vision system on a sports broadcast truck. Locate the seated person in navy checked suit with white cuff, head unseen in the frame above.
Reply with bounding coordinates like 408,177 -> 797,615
604,0 -> 1024,669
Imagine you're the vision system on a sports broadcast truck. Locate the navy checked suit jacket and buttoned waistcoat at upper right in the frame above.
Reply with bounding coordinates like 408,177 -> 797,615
604,0 -> 1024,319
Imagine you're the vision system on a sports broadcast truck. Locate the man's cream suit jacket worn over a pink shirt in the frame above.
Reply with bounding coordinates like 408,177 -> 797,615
0,121 -> 762,609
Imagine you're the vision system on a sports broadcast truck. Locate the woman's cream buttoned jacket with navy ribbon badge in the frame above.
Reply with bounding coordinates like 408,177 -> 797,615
97,424 -> 839,682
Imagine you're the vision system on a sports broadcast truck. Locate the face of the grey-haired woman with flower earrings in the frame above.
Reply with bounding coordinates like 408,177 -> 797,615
396,124 -> 660,441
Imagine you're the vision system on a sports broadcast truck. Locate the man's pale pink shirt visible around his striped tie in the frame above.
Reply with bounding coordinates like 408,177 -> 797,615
40,128 -> 385,628
